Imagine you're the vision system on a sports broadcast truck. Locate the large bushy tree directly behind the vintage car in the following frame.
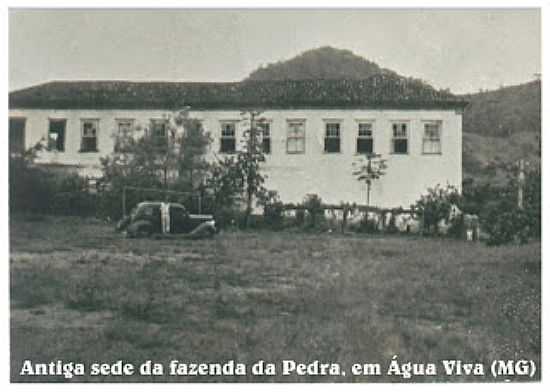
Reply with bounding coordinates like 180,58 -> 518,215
101,108 -> 210,217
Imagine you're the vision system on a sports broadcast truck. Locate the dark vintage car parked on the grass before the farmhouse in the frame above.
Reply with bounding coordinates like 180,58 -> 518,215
116,201 -> 218,238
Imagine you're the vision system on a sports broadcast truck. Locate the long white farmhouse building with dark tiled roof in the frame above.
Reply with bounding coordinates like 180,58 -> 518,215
9,75 -> 465,208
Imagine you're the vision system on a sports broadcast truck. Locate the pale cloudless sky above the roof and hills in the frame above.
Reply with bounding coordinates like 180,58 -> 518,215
8,9 -> 541,93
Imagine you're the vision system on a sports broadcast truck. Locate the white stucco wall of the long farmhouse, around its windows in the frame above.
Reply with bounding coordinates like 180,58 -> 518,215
10,109 -> 462,207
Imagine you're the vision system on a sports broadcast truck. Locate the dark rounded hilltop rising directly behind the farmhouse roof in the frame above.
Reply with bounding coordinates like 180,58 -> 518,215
246,46 -> 398,80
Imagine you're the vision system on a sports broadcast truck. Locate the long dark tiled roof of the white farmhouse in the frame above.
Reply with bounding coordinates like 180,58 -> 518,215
9,75 -> 466,110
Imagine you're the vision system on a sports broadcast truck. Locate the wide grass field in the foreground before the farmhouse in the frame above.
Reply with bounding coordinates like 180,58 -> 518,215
10,217 -> 541,382
